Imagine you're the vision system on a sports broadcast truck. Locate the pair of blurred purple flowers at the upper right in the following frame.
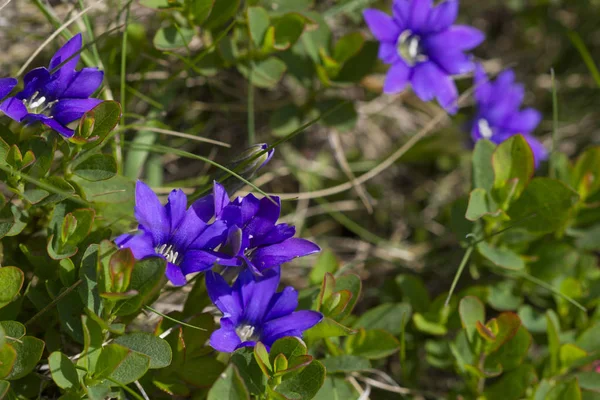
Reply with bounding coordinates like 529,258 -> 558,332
364,0 -> 548,166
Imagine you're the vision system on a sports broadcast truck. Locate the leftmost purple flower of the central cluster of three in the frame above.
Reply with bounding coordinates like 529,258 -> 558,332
115,181 -> 227,286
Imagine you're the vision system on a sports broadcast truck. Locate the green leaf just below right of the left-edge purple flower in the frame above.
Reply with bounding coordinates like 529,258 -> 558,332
78,100 -> 121,150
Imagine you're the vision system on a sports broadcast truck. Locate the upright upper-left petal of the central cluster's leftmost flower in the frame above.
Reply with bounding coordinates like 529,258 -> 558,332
134,181 -> 170,246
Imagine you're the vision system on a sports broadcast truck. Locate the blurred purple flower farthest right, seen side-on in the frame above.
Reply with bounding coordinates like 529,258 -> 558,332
471,65 -> 548,166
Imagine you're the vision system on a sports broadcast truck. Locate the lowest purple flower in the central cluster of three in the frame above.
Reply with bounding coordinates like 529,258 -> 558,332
206,268 -> 323,353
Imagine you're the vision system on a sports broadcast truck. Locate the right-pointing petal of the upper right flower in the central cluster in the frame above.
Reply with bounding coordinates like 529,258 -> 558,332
251,238 -> 321,271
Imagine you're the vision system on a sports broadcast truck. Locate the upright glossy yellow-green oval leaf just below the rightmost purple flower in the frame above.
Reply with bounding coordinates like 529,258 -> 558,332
492,135 -> 535,208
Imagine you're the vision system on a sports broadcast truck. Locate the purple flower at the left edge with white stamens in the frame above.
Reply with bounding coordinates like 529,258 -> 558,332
0,34 -> 104,138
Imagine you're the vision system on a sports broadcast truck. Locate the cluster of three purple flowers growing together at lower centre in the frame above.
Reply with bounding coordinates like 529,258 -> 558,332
115,153 -> 322,352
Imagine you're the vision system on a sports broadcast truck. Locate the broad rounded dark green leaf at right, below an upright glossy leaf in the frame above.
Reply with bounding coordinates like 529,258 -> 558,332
508,178 -> 578,233
